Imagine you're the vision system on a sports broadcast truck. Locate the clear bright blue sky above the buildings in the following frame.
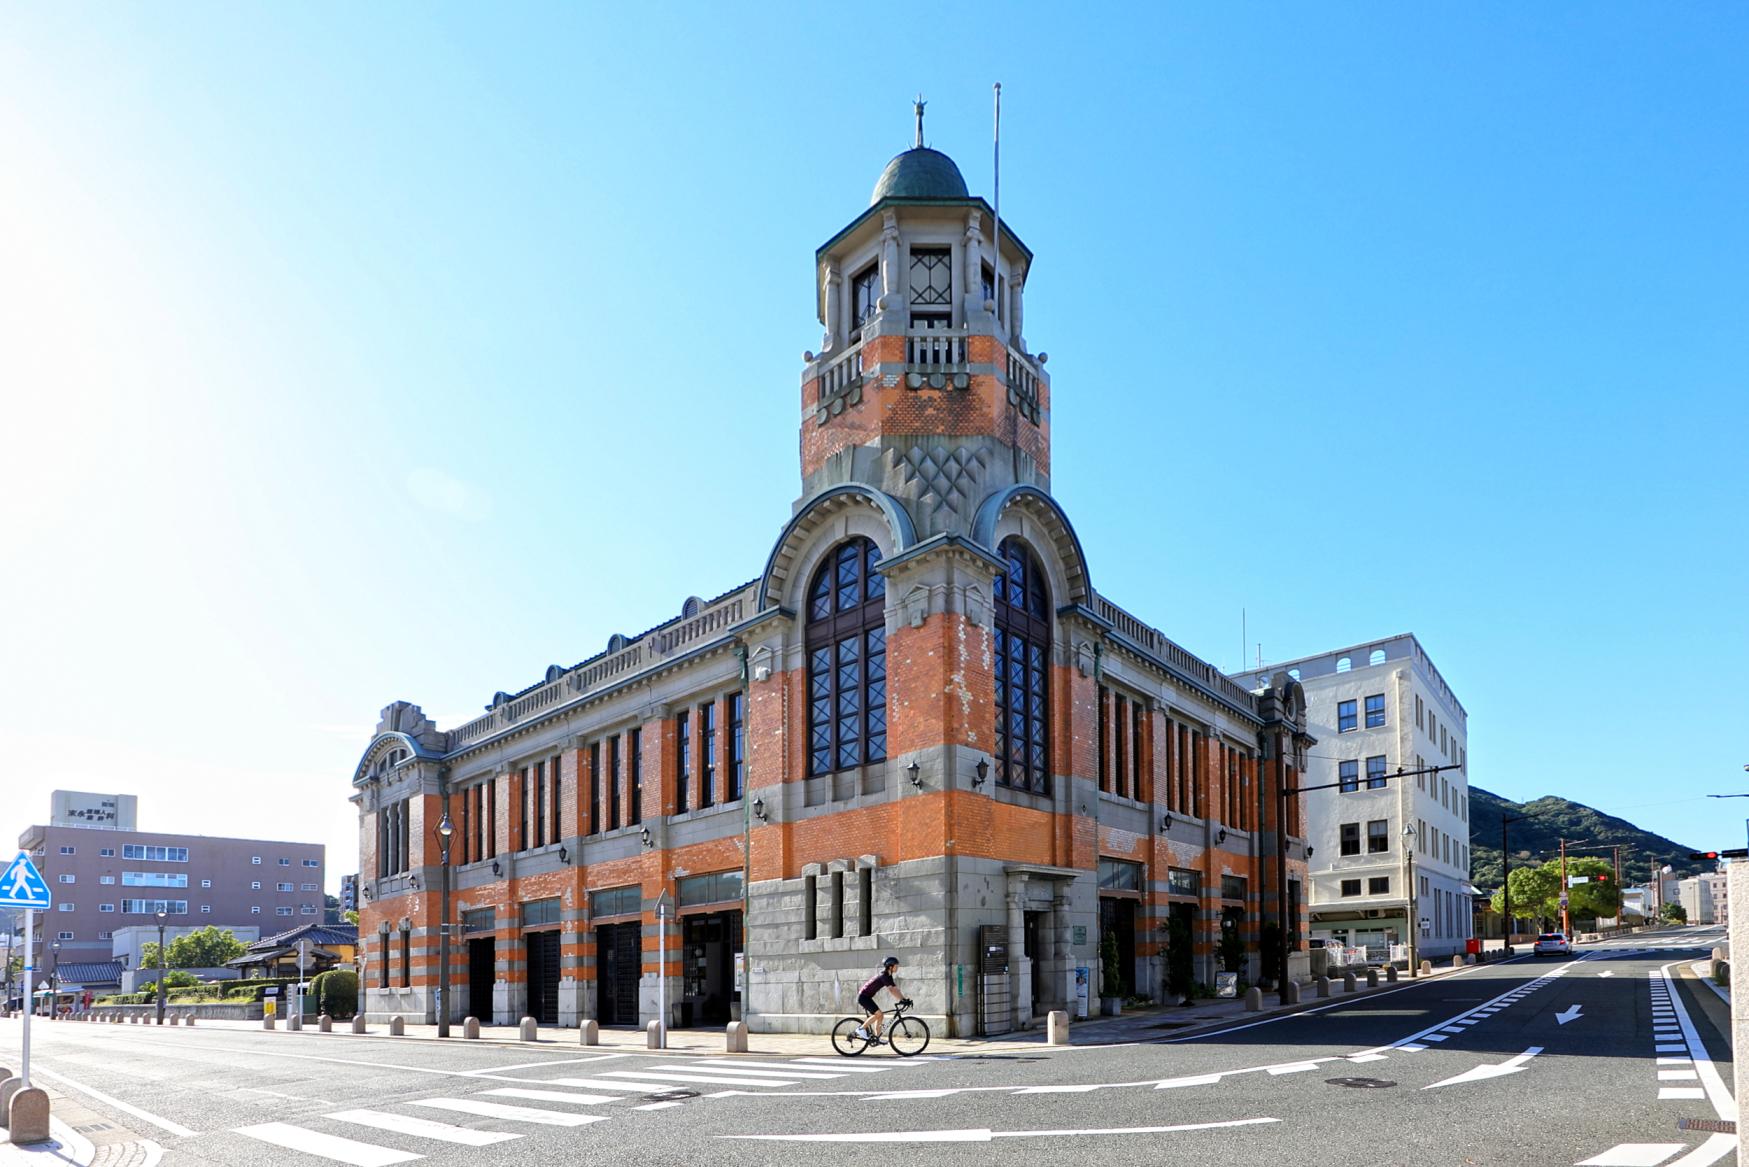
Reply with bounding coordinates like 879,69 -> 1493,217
0,3 -> 1749,895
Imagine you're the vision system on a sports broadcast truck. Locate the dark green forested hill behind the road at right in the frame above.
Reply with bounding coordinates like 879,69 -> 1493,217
1469,786 -> 1714,892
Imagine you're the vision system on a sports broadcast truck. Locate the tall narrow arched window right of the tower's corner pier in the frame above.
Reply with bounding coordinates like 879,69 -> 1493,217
995,537 -> 1051,794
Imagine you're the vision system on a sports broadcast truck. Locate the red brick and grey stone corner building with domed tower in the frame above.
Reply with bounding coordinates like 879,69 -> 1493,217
353,116 -> 1310,1034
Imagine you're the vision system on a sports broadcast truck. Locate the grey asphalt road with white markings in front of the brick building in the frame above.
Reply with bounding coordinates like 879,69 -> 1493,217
0,929 -> 1735,1167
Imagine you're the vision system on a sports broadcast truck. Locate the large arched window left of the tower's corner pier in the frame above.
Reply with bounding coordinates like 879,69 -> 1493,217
806,539 -> 887,773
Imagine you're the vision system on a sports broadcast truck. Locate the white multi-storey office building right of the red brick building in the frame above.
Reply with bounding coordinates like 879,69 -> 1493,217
1237,633 -> 1476,957
